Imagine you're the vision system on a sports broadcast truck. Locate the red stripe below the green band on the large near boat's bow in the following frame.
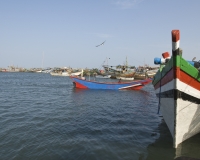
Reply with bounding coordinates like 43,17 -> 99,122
154,67 -> 200,90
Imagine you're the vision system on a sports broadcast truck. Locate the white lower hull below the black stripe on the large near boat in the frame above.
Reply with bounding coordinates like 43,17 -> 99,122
160,98 -> 200,148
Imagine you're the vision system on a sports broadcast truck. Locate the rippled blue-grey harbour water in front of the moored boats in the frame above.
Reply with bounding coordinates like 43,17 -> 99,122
0,73 -> 200,160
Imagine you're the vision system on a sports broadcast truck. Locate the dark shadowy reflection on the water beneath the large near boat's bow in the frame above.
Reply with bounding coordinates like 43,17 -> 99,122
146,119 -> 200,160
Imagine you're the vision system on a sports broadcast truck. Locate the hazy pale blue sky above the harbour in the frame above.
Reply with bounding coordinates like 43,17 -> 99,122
0,0 -> 200,69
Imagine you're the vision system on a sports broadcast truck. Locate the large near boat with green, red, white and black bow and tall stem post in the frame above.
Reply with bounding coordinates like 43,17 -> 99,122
152,30 -> 200,148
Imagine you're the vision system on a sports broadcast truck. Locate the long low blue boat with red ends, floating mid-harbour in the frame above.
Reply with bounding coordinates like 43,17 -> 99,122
70,76 -> 152,90
